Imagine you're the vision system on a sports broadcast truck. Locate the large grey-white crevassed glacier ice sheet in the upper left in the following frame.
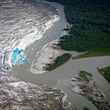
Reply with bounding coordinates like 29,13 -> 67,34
0,0 -> 60,65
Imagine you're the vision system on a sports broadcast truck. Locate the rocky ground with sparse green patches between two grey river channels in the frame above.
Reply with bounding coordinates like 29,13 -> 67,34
71,71 -> 110,110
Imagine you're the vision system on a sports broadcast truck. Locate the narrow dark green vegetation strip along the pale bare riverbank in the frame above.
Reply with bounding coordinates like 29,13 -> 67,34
45,53 -> 71,71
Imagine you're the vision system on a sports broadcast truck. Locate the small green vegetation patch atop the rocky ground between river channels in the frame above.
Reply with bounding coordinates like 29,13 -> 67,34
79,71 -> 92,81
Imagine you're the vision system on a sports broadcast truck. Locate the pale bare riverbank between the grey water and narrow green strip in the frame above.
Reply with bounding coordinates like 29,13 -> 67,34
30,40 -> 64,74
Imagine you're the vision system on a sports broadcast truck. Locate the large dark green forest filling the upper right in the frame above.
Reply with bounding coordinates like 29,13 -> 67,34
49,0 -> 110,51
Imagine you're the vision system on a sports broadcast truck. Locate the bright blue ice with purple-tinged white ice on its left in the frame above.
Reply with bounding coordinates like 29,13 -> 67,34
0,48 -> 28,73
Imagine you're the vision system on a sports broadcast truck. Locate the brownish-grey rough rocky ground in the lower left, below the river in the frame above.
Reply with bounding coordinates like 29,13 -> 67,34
0,73 -> 70,110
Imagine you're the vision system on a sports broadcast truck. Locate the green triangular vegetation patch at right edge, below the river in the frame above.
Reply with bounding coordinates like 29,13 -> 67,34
98,66 -> 110,83
